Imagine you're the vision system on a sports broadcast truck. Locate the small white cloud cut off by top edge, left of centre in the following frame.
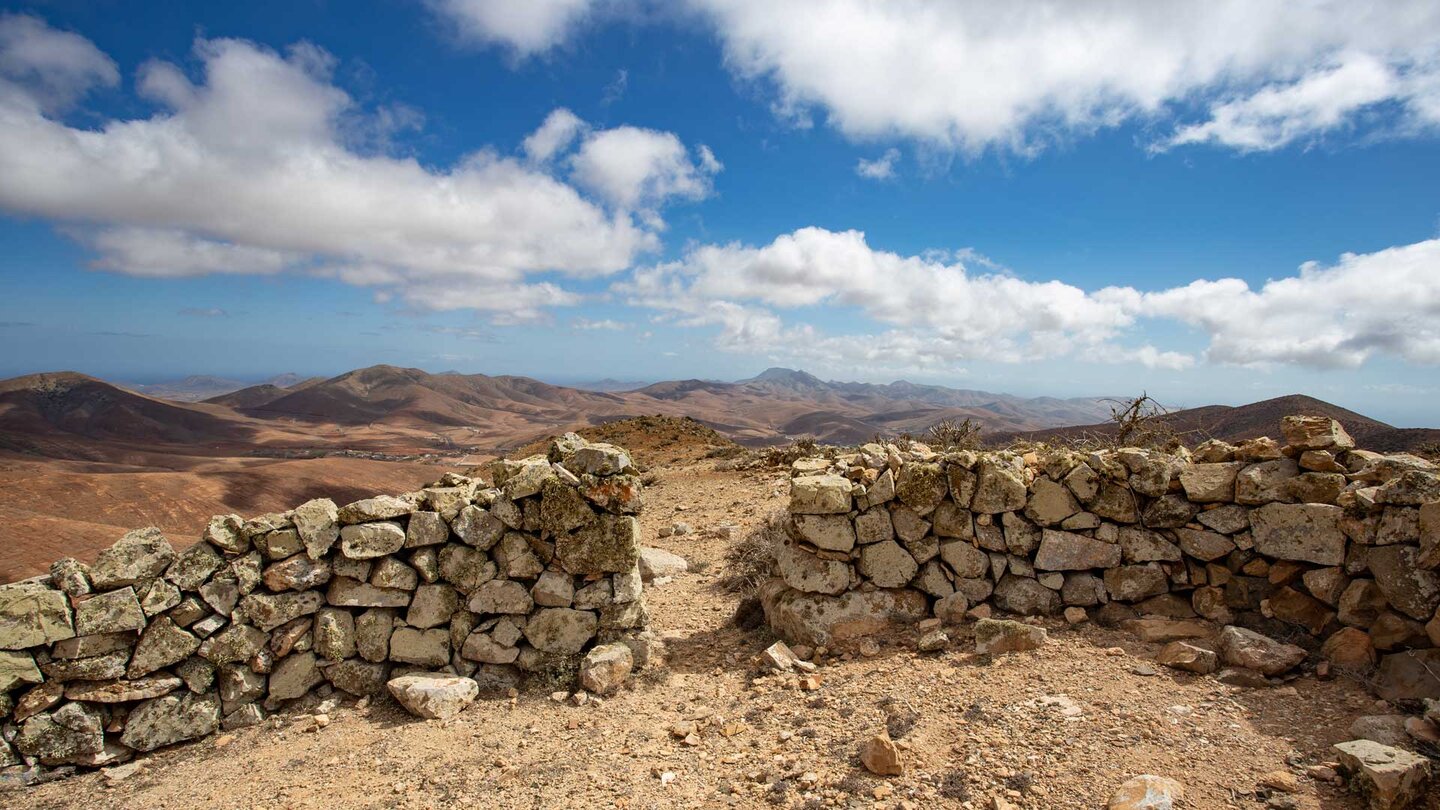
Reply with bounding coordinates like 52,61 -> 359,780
429,0 -> 599,56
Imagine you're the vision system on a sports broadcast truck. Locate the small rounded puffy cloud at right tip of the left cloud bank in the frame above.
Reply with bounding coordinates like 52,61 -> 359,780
570,127 -> 721,212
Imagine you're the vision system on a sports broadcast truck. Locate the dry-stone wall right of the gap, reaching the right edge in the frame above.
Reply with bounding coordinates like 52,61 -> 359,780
762,417 -> 1440,698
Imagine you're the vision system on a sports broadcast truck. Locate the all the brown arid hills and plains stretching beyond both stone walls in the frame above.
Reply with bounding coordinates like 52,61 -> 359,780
0,366 -> 1440,579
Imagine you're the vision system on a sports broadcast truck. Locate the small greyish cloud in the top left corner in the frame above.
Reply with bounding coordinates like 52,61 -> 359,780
0,14 -> 120,112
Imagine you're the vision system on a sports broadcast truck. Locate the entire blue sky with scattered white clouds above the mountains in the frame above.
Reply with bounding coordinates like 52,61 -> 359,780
0,0 -> 1440,427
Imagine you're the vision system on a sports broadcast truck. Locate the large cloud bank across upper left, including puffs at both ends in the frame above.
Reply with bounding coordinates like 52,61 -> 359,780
0,16 -> 707,321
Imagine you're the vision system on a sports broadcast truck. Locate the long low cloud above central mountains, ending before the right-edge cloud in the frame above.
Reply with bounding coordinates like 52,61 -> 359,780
618,228 -> 1192,368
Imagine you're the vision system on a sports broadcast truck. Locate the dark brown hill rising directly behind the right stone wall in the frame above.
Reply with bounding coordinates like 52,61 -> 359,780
989,393 -> 1440,453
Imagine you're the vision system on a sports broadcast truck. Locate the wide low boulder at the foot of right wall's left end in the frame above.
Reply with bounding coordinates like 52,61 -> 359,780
760,579 -> 929,647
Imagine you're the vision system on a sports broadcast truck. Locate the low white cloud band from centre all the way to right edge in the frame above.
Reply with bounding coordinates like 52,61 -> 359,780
616,228 -> 1440,370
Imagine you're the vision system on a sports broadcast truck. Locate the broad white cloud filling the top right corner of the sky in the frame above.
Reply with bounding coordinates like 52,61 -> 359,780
690,0 -> 1440,153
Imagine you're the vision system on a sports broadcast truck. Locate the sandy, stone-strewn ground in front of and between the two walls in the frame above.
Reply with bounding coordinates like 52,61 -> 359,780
0,447 -> 1440,810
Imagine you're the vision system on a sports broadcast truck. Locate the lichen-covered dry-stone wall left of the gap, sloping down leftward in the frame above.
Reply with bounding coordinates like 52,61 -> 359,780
0,434 -> 651,770
